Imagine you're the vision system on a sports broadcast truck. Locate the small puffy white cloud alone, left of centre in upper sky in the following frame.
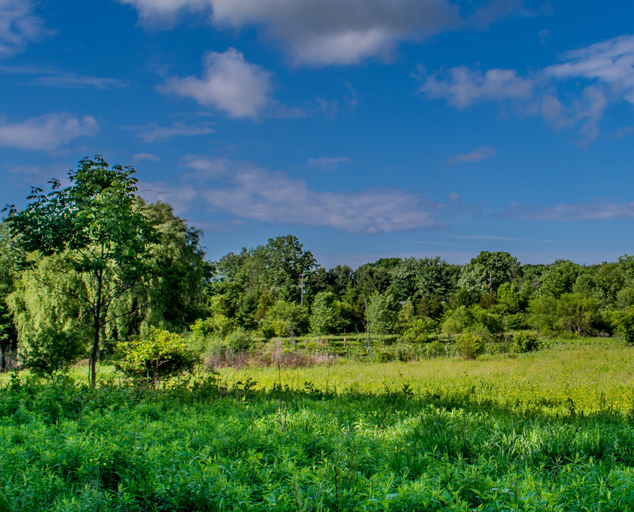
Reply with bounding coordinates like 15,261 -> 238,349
159,48 -> 272,119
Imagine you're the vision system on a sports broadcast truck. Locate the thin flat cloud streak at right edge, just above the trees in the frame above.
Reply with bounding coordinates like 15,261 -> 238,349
499,201 -> 634,222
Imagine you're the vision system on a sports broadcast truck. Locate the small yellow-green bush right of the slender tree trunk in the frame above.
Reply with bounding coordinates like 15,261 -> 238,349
115,329 -> 199,386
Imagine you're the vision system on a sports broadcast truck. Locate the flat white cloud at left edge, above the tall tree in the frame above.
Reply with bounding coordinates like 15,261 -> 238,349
0,112 -> 99,151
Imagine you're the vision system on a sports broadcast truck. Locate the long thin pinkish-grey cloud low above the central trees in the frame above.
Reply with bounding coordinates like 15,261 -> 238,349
148,156 -> 446,234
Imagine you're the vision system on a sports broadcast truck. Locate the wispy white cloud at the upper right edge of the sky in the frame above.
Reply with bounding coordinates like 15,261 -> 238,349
417,34 -> 634,144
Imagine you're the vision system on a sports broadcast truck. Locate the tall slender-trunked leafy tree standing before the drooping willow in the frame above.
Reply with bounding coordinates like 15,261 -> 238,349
7,156 -> 157,386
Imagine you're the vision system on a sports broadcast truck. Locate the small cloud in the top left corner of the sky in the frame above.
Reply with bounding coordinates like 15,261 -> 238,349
0,0 -> 51,57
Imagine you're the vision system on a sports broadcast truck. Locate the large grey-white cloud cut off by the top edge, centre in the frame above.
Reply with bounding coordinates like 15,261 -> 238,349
119,0 -> 521,66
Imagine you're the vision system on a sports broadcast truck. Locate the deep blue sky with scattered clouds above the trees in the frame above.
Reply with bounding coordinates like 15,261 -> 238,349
0,0 -> 634,266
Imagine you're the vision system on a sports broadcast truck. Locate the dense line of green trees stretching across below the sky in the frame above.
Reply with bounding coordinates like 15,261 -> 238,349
0,157 -> 634,378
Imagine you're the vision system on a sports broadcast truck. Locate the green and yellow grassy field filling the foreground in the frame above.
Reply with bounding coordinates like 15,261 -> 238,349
0,340 -> 634,512
